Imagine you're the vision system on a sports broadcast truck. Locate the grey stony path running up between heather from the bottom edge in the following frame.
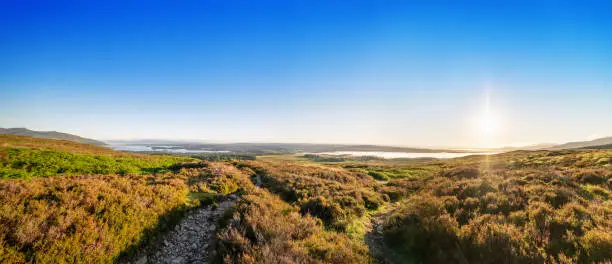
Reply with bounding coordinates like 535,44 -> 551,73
125,196 -> 236,264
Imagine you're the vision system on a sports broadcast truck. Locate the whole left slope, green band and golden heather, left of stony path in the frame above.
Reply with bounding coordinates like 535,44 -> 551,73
0,135 -> 195,263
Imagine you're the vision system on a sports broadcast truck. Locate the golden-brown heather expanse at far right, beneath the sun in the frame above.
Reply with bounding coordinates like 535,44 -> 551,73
384,151 -> 612,263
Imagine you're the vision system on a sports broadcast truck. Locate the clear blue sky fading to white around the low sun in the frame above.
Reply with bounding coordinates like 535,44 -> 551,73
0,0 -> 612,146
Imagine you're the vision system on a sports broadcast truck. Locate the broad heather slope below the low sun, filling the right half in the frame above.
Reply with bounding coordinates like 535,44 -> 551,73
256,150 -> 612,263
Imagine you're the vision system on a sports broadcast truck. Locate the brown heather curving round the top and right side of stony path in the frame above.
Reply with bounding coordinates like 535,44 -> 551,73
160,162 -> 370,263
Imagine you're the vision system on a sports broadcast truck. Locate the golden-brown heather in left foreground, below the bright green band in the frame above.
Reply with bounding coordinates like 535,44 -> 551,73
0,175 -> 187,263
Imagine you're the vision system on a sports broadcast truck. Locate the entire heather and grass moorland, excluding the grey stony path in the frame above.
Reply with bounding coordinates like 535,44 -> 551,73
0,135 -> 612,263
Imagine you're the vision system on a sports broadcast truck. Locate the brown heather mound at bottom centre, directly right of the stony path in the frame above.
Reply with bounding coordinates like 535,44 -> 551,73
217,178 -> 369,263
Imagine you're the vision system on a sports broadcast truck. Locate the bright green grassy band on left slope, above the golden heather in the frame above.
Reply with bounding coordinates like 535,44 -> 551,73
0,135 -> 192,178
